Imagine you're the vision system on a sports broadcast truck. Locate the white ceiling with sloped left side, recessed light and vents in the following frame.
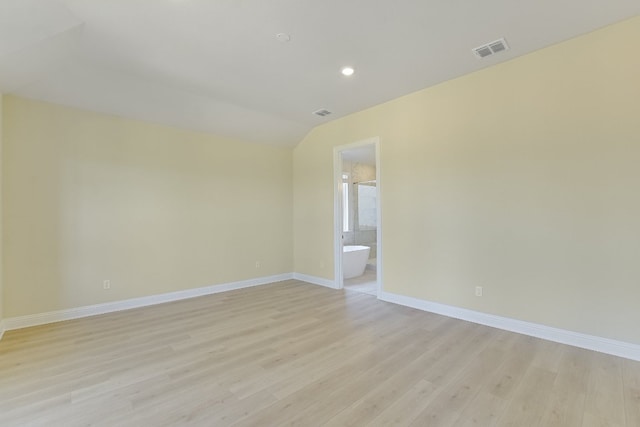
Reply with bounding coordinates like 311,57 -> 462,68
0,0 -> 640,146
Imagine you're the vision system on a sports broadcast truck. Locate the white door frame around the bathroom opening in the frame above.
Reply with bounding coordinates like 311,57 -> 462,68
333,137 -> 382,298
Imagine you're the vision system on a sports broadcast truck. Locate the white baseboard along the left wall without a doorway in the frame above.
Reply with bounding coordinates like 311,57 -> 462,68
0,273 -> 293,338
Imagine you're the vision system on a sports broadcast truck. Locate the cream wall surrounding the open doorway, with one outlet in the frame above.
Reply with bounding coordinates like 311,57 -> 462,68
294,17 -> 640,344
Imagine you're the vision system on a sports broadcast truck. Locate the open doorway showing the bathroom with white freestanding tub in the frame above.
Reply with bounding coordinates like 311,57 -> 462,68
334,138 -> 382,296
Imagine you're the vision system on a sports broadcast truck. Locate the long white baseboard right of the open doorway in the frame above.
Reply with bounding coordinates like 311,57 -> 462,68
378,292 -> 640,361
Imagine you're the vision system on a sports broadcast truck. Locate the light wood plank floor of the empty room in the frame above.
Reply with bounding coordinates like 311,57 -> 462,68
0,280 -> 640,427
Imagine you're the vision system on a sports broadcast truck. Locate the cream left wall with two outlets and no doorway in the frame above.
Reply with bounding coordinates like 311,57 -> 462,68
3,96 -> 292,317
